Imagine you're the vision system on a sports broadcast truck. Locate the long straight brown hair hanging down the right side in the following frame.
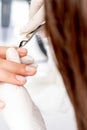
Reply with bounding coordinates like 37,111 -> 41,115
45,0 -> 87,130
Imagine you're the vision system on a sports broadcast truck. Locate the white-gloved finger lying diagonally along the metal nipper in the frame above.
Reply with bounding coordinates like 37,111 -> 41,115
20,5 -> 45,34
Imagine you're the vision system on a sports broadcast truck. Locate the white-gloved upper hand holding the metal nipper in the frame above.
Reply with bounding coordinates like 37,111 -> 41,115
21,0 -> 45,35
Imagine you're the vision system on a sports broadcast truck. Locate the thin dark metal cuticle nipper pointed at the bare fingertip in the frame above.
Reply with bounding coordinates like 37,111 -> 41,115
19,22 -> 45,48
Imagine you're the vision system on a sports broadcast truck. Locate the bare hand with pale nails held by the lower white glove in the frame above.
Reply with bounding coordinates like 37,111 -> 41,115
0,46 -> 36,109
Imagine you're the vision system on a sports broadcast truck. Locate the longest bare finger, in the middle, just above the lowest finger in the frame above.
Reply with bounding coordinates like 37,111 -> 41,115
0,59 -> 36,76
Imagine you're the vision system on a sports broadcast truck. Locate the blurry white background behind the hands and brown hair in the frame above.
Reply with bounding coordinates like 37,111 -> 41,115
0,0 -> 76,130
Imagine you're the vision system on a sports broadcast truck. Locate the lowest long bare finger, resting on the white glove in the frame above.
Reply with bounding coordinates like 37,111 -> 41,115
0,69 -> 26,85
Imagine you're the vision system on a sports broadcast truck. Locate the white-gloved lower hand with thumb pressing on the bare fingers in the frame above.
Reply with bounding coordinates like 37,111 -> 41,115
0,48 -> 46,130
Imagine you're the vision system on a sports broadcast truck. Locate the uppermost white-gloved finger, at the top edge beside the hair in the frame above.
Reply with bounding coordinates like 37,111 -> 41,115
29,0 -> 44,19
